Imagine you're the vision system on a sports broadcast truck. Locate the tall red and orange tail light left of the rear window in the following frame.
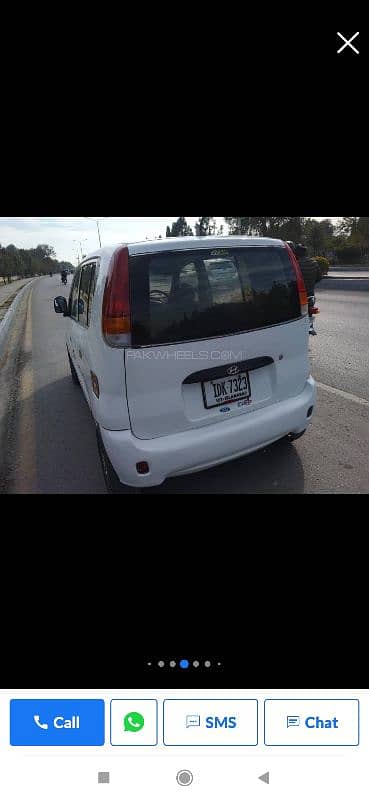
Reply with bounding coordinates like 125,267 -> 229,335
102,247 -> 131,347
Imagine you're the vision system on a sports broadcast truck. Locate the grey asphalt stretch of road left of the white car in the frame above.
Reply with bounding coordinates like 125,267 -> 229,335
0,276 -> 105,494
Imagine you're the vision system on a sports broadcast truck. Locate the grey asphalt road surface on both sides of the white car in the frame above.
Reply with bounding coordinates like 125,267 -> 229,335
0,277 -> 369,494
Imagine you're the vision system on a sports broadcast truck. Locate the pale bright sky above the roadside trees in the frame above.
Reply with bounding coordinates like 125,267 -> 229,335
0,217 -> 337,265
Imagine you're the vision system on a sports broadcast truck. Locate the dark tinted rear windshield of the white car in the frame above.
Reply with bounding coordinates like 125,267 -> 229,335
130,247 -> 300,347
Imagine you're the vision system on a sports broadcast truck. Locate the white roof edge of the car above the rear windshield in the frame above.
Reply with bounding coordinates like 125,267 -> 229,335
83,236 -> 285,262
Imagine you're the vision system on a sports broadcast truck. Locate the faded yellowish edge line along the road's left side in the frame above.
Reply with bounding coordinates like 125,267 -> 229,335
12,287 -> 37,494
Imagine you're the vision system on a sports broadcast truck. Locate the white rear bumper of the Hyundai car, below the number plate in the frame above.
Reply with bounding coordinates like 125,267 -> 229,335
100,376 -> 316,487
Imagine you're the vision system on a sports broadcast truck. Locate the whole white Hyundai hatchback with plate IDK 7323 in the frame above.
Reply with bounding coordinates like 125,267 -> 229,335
54,236 -> 316,492
